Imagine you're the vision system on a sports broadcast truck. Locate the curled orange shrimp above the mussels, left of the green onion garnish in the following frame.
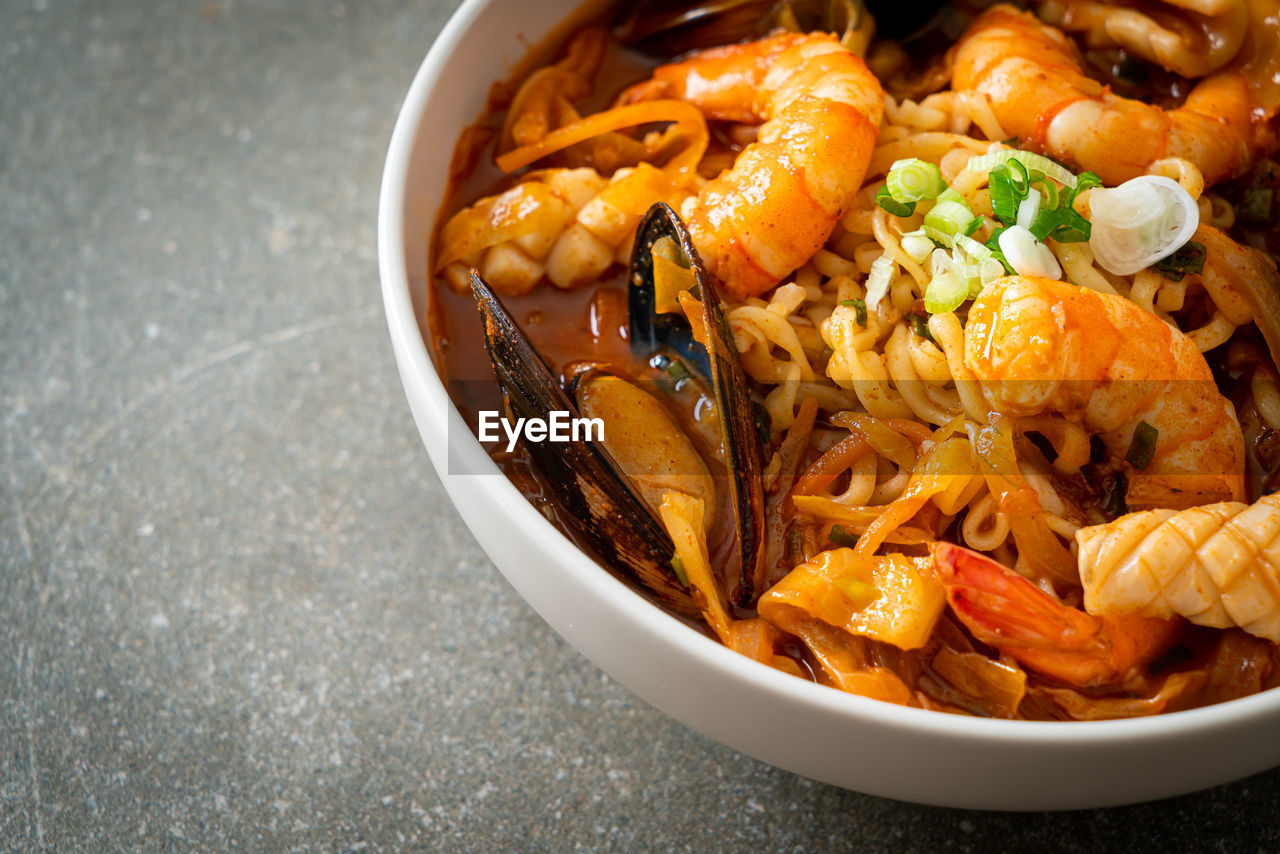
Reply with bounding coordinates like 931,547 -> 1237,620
622,33 -> 884,298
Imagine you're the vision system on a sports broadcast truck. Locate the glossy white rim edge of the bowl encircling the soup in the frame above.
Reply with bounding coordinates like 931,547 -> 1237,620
378,0 -> 1280,746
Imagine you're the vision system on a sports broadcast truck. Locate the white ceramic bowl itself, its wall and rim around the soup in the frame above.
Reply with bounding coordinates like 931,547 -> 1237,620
378,0 -> 1280,809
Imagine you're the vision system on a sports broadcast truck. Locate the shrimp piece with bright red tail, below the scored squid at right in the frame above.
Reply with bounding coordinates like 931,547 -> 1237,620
933,543 -> 1181,688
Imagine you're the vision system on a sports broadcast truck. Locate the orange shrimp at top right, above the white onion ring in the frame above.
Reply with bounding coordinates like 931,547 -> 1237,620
951,5 -> 1275,186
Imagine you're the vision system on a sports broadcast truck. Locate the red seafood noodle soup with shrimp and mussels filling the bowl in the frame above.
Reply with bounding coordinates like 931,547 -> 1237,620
428,0 -> 1280,720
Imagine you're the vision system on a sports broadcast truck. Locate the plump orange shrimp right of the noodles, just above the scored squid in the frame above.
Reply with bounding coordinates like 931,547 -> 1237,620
964,275 -> 1244,508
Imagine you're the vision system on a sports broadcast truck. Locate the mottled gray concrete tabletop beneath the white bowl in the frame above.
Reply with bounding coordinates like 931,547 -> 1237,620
0,0 -> 1280,851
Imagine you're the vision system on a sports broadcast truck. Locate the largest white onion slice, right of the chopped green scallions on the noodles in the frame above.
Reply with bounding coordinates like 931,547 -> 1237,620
1089,175 -> 1199,275
